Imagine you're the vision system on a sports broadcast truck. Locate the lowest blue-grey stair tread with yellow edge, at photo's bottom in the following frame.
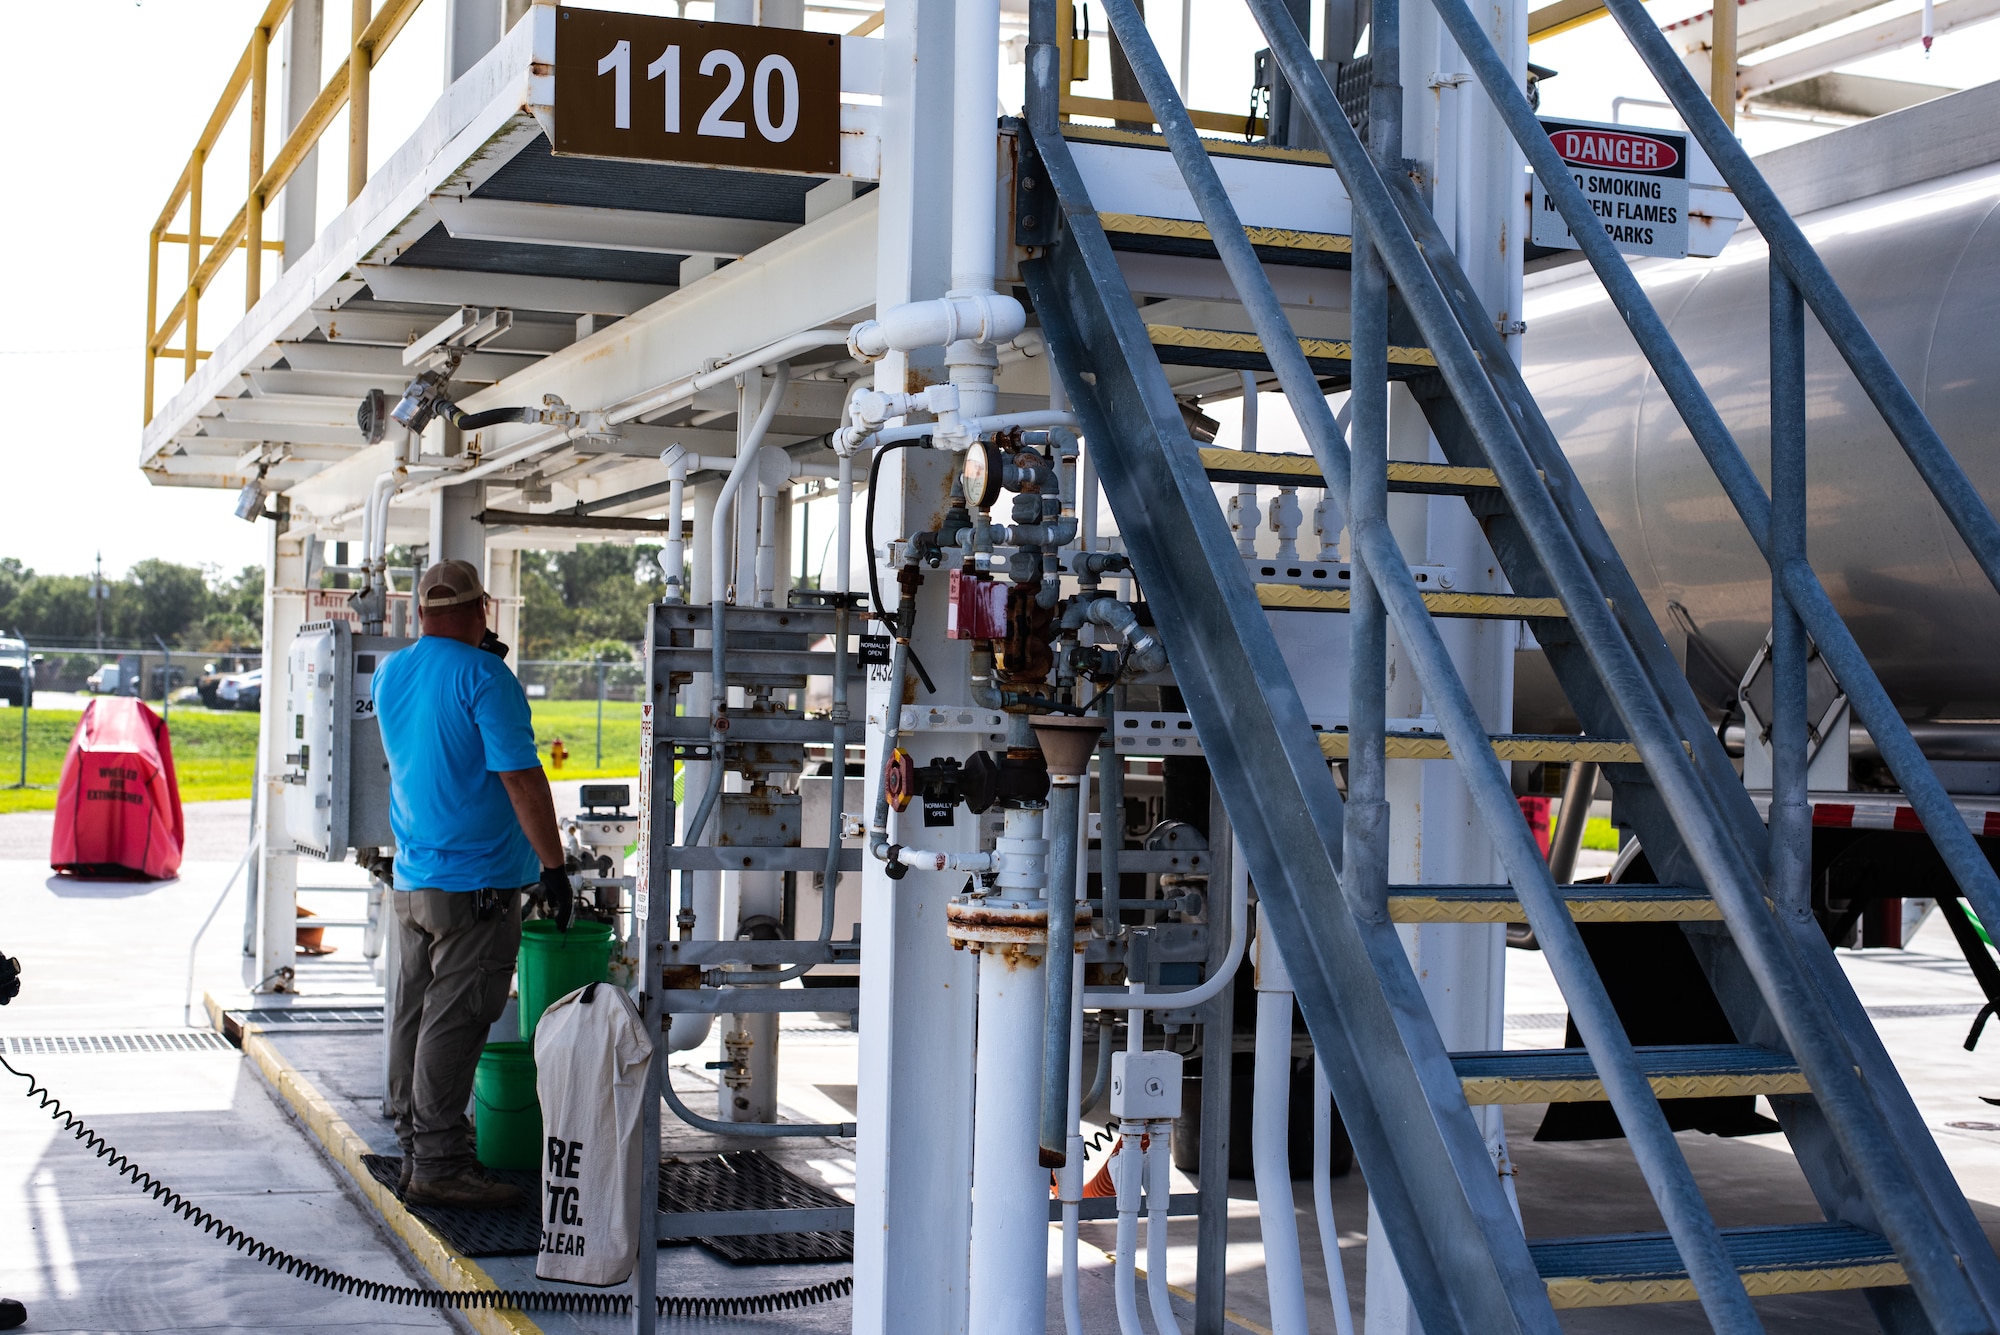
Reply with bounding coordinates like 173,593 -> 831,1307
1528,1223 -> 1906,1309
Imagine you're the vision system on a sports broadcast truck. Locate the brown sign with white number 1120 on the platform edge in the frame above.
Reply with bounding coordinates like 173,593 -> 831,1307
554,6 -> 840,176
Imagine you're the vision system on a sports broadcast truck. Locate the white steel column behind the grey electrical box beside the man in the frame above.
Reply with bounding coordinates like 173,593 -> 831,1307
244,524 -> 306,991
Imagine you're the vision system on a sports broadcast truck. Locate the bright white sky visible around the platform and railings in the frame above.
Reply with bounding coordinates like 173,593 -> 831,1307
0,0 -> 2000,572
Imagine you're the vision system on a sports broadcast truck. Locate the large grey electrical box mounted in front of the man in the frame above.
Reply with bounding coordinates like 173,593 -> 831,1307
282,622 -> 412,861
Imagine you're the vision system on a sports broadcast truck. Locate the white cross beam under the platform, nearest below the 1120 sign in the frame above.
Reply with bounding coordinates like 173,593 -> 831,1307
432,198 -> 796,259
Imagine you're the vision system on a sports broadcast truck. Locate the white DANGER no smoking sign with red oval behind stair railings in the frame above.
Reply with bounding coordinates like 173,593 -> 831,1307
1528,120 -> 1688,260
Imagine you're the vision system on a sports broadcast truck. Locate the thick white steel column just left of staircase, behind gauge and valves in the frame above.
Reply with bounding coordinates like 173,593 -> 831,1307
854,0 -> 976,1335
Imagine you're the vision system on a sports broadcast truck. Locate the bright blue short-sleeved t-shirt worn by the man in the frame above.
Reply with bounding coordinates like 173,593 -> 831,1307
374,636 -> 542,889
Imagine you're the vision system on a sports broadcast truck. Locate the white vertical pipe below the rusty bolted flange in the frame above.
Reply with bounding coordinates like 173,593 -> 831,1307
966,945 -> 1048,1335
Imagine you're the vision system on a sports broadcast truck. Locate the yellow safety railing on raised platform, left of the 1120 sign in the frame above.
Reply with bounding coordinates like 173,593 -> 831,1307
146,0 -> 424,422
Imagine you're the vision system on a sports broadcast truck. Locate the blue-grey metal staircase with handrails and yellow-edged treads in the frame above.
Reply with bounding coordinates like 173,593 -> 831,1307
1016,0 -> 2000,1335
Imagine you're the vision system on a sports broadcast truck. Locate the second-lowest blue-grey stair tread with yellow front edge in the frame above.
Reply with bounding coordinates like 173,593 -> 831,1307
1452,1043 -> 1808,1103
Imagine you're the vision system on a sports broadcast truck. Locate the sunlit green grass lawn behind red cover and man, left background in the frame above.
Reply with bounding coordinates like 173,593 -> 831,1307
0,699 -> 638,813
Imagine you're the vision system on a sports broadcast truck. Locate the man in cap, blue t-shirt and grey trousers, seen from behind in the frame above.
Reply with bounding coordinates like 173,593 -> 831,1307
374,562 -> 570,1209
